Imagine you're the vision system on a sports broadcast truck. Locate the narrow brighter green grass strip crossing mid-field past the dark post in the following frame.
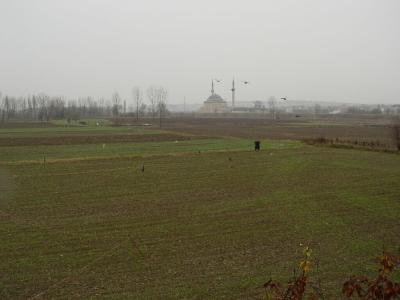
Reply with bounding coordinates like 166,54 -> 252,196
0,138 -> 301,163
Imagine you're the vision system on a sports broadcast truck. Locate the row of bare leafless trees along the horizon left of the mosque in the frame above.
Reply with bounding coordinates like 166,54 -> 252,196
0,85 -> 168,123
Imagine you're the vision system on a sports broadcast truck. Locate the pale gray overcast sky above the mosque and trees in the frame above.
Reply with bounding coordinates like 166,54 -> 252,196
0,0 -> 400,103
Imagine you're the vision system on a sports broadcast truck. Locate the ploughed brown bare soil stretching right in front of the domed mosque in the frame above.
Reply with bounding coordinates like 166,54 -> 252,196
157,118 -> 393,143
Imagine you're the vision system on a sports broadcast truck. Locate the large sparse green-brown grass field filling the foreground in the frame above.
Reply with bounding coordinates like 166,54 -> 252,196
0,120 -> 400,299
